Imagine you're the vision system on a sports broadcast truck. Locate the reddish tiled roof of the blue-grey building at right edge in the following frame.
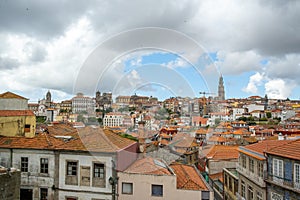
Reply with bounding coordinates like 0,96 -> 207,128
266,139 -> 300,160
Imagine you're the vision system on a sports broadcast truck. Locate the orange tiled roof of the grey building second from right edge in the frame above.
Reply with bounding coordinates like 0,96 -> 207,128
238,140 -> 289,160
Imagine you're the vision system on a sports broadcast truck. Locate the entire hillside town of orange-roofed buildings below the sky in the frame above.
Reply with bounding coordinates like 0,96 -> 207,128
0,78 -> 300,200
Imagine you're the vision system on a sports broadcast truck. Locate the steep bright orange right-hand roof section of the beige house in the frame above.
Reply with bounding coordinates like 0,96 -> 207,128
170,164 -> 208,190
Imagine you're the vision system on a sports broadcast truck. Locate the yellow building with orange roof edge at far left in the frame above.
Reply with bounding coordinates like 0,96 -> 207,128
0,110 -> 36,137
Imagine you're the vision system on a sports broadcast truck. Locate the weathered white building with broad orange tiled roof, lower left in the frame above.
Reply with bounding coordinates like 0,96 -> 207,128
0,124 -> 137,200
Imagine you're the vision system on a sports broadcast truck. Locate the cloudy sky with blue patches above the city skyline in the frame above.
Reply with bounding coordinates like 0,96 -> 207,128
0,0 -> 300,102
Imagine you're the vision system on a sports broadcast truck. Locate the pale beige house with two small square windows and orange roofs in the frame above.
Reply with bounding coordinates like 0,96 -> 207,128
118,157 -> 213,200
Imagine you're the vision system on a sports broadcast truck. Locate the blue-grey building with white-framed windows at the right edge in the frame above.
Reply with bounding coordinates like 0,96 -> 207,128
266,139 -> 300,200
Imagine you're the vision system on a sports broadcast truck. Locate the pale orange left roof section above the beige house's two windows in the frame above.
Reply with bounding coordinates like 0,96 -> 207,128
124,157 -> 172,175
